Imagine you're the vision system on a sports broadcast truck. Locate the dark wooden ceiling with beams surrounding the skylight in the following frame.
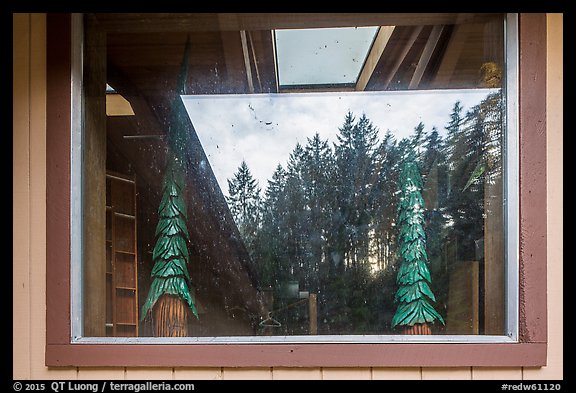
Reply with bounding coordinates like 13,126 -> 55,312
100,14 -> 501,96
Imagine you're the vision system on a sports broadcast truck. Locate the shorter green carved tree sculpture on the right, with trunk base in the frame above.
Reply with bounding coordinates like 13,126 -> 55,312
392,152 -> 444,334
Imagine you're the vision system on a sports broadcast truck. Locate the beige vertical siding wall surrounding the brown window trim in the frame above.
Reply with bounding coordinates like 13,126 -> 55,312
12,14 -> 563,380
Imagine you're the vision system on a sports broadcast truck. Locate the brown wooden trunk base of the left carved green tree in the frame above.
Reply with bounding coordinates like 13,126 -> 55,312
153,295 -> 188,337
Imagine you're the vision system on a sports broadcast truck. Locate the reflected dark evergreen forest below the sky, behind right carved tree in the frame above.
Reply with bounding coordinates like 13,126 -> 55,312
192,90 -> 503,335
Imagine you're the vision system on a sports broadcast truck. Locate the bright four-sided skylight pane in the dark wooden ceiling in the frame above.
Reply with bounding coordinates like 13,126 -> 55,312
275,27 -> 378,88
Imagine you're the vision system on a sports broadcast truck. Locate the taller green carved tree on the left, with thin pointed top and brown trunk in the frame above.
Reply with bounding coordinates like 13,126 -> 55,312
141,38 -> 198,337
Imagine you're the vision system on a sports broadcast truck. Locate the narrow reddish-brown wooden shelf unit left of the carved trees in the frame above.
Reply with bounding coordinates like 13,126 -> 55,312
106,172 -> 138,337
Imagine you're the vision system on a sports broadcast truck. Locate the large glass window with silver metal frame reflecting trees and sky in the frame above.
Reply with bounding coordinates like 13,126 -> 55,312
47,14 -> 548,364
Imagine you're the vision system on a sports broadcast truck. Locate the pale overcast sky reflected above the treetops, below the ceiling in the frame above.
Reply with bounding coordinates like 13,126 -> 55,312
182,89 -> 490,195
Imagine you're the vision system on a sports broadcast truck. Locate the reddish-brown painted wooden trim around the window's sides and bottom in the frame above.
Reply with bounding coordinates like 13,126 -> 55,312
45,14 -> 547,367
